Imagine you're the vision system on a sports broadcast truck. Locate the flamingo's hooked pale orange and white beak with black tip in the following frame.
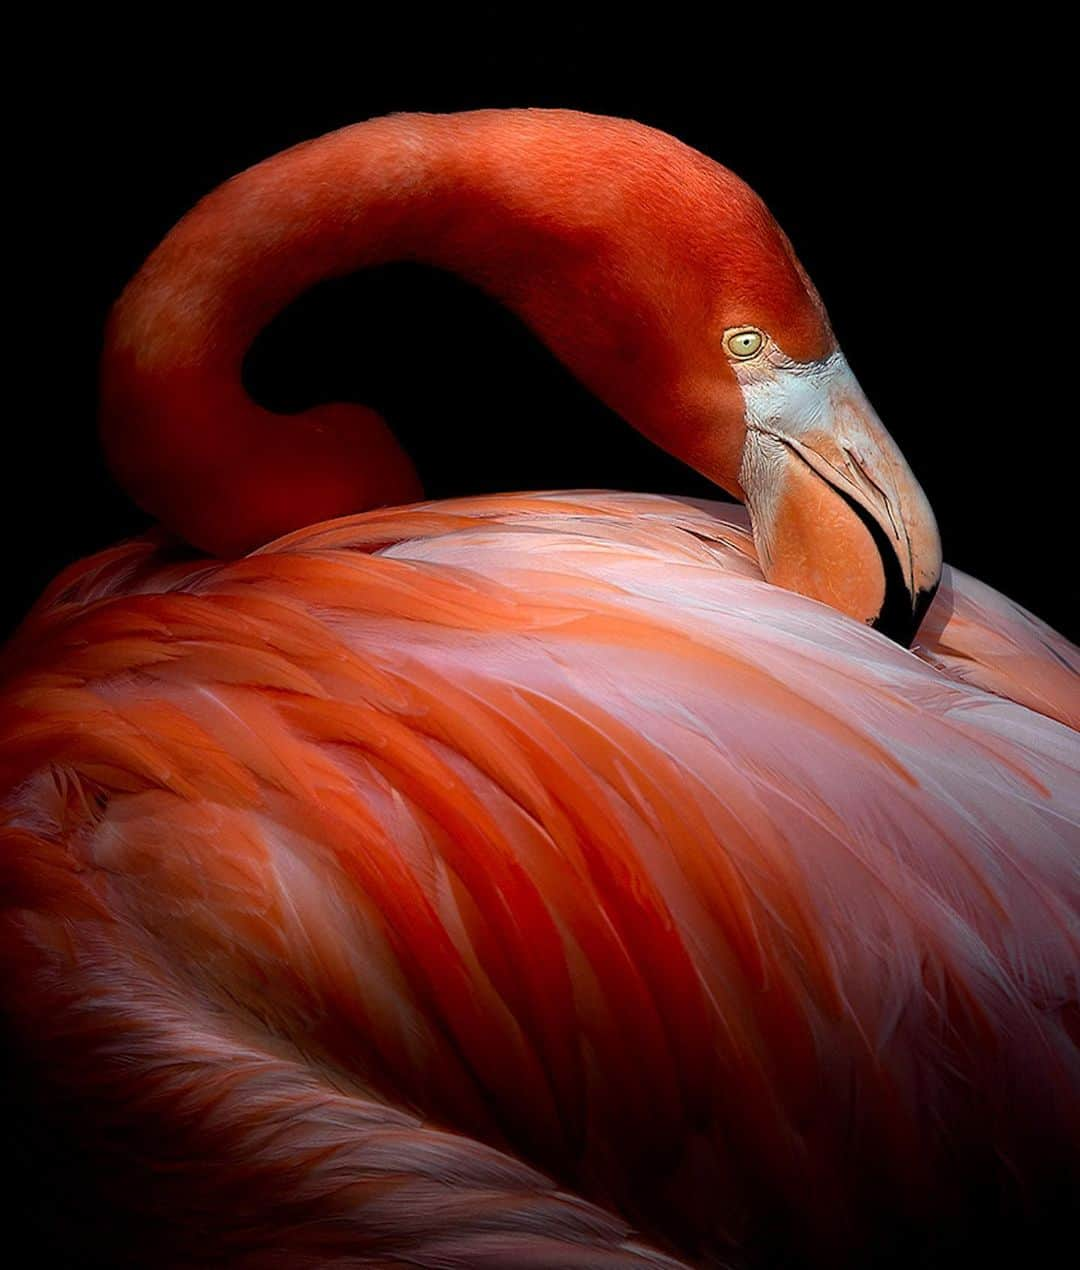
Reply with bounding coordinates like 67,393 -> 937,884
736,351 -> 942,645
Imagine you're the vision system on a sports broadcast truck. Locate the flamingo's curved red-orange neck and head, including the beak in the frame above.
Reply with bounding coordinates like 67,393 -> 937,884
102,110 -> 942,643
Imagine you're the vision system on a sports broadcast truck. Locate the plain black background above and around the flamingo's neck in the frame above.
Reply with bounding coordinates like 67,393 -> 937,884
4,21 -> 1076,638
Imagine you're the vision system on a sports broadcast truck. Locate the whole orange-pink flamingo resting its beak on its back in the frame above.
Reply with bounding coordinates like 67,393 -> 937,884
0,110 -> 1080,1267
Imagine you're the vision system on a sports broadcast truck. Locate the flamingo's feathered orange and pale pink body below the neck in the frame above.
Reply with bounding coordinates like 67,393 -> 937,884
0,494 -> 1080,1267
